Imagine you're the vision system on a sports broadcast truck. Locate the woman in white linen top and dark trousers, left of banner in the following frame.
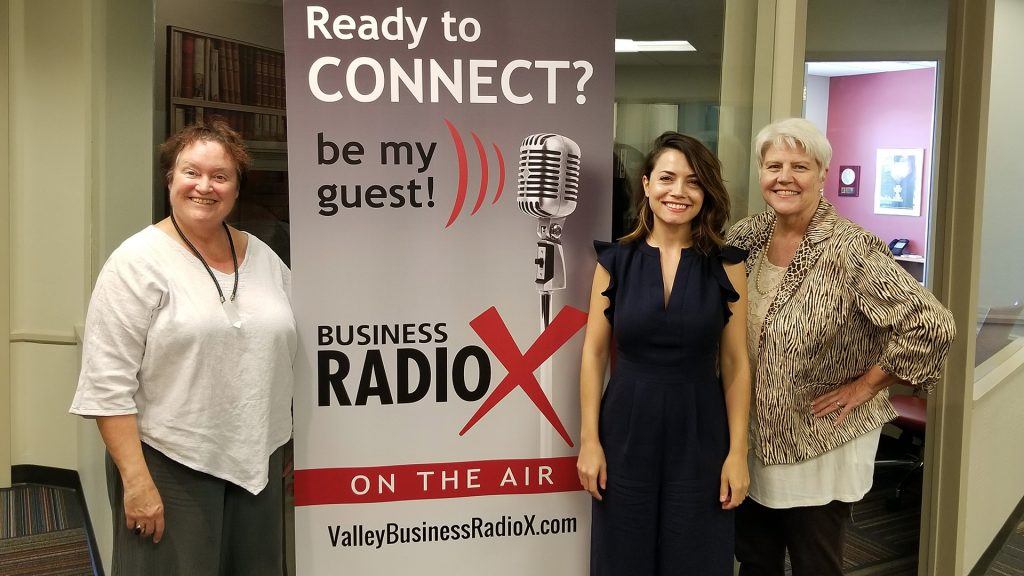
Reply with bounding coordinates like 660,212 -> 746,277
71,121 -> 296,574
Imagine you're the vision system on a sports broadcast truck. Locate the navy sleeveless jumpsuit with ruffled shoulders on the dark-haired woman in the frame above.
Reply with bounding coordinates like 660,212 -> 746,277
590,240 -> 745,576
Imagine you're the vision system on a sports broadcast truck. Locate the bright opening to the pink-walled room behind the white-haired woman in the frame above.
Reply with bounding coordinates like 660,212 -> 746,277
804,60 -> 938,284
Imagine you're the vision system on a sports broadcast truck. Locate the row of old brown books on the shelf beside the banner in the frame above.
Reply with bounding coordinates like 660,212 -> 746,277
168,30 -> 285,110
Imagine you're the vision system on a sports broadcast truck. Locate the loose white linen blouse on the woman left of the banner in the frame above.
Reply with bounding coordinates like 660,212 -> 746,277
71,227 -> 296,494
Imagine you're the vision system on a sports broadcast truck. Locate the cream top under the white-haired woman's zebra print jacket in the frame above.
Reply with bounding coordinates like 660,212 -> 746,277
746,250 -> 882,508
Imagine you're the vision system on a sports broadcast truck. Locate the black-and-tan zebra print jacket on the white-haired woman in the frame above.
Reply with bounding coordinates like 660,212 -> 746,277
726,198 -> 955,465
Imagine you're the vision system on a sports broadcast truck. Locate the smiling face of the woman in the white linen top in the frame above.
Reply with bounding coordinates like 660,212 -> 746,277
167,140 -> 239,228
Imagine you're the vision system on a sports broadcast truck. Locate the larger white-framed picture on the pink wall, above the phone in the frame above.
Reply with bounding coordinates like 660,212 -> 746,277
874,148 -> 925,216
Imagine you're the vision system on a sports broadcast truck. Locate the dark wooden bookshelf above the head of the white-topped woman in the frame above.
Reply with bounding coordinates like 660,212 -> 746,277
167,26 -> 287,147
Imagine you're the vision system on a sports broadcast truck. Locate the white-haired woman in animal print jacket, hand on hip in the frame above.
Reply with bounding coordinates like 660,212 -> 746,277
727,118 -> 954,576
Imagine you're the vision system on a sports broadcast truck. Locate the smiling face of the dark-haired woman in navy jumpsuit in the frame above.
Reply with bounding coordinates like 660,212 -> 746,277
643,149 -> 703,231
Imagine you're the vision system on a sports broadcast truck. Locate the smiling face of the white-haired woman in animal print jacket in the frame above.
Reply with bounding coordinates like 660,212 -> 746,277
760,146 -> 828,221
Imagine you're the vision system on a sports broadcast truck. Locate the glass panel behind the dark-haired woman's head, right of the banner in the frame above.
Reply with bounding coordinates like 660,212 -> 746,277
612,0 -> 757,238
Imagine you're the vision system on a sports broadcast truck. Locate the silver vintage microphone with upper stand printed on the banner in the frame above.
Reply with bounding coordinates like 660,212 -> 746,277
516,134 -> 580,328
